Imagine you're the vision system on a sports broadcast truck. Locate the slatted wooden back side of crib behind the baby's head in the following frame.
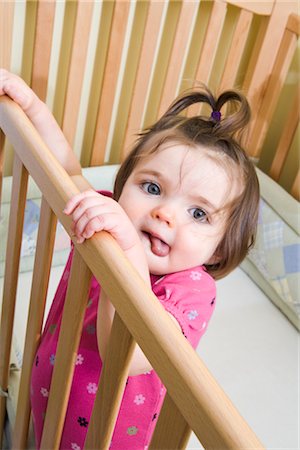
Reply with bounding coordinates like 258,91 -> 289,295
0,0 -> 298,199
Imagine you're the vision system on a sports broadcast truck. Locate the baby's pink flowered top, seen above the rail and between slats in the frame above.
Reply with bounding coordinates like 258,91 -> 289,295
31,222 -> 216,450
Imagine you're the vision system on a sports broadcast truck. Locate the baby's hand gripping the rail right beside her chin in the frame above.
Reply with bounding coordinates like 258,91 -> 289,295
64,189 -> 139,251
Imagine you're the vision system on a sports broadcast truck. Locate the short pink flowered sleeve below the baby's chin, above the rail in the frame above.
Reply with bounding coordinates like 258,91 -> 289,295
152,267 -> 216,348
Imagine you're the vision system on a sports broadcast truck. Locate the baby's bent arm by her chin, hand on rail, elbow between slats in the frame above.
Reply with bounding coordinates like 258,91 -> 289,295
64,190 -> 151,375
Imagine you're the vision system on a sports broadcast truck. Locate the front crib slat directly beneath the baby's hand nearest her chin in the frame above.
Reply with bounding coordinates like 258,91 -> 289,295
41,250 -> 92,450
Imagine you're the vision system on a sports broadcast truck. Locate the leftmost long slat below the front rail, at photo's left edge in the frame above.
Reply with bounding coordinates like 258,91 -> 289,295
0,155 -> 28,439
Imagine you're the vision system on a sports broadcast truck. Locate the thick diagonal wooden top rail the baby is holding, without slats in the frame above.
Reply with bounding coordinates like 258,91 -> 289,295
0,97 -> 263,450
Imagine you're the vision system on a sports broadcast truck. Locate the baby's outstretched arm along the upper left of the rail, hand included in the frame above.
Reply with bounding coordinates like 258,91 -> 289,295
0,69 -> 81,175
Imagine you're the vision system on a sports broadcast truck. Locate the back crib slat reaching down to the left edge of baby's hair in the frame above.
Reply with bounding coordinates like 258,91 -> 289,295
121,1 -> 165,159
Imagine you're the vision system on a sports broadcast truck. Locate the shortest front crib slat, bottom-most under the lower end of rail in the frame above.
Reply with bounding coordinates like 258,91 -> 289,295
149,393 -> 191,450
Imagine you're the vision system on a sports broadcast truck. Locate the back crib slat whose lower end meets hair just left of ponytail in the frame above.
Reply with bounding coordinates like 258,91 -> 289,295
158,0 -> 199,117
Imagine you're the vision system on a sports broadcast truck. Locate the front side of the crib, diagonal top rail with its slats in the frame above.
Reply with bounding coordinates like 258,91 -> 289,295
0,98 -> 263,450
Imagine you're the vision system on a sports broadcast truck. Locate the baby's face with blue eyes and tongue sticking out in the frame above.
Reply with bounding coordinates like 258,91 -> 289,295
119,143 -> 241,275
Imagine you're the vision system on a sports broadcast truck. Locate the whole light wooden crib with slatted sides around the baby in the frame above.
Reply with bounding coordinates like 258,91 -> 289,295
0,0 -> 299,449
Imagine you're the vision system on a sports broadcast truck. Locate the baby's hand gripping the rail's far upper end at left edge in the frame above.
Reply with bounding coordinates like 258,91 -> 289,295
0,69 -> 42,118
